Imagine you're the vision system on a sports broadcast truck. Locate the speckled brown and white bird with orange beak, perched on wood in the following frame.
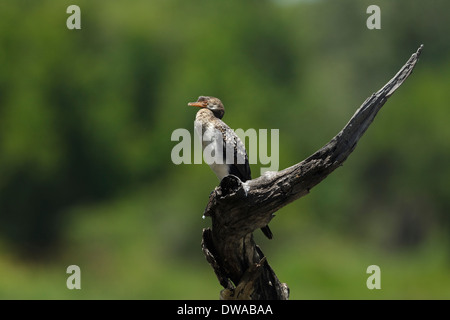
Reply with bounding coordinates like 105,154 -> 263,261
188,96 -> 273,239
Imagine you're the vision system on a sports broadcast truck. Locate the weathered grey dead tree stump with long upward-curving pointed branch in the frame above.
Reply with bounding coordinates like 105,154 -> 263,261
202,46 -> 423,300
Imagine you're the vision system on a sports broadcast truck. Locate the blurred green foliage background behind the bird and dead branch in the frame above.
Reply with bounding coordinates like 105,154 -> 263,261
0,0 -> 450,299
